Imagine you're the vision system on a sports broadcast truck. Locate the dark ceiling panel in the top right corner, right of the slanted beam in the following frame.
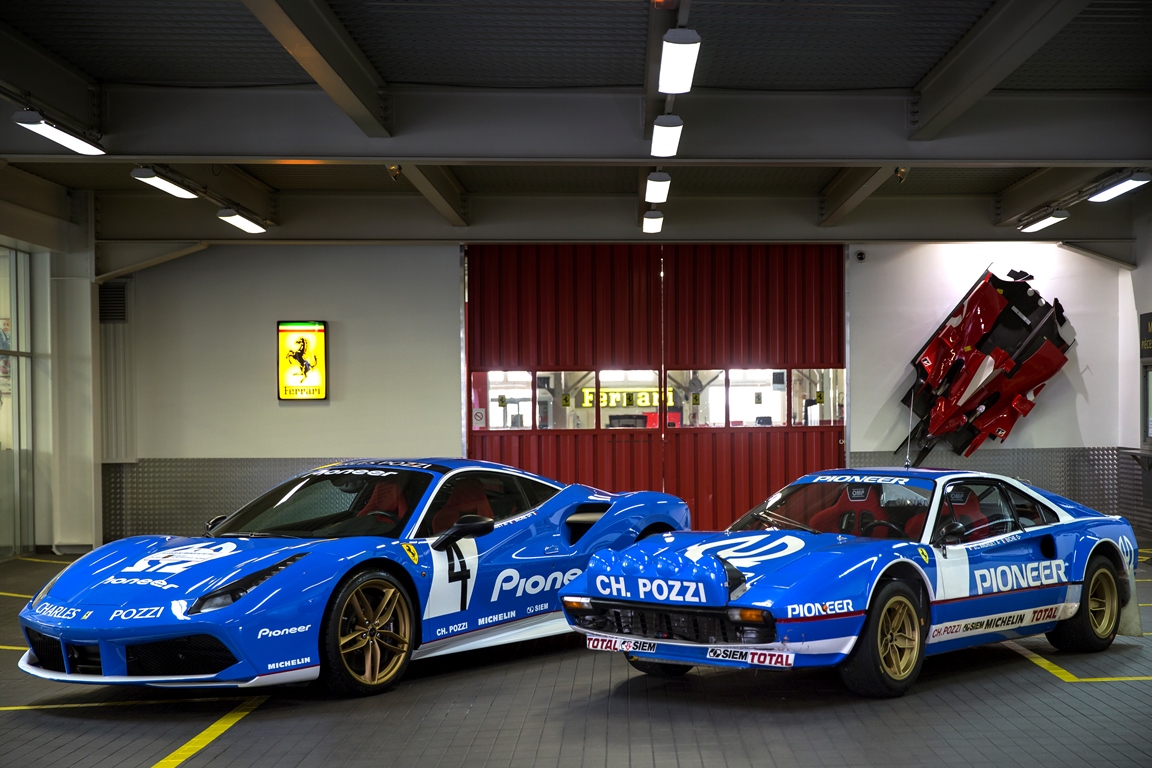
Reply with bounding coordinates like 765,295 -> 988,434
999,0 -> 1152,91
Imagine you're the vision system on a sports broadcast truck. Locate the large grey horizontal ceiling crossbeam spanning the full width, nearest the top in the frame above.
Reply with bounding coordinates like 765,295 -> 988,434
0,86 -> 1152,168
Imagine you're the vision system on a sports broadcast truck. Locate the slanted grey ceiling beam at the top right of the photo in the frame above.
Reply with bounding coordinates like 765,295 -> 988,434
910,0 -> 1091,140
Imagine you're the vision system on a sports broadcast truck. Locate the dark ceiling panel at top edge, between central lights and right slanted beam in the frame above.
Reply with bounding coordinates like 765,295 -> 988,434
688,0 -> 992,90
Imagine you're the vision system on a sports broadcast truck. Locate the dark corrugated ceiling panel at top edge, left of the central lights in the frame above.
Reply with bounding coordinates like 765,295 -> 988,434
329,0 -> 649,88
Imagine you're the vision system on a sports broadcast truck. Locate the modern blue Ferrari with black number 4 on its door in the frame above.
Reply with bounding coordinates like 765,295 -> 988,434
20,459 -> 689,695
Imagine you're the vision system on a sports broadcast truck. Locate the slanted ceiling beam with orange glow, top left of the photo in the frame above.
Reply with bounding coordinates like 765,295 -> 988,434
244,0 -> 392,138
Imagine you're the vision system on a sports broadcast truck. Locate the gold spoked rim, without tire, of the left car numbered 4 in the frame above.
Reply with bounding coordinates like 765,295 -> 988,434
340,579 -> 412,685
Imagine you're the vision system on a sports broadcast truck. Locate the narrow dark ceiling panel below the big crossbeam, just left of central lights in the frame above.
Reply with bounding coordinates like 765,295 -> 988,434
452,166 -> 639,195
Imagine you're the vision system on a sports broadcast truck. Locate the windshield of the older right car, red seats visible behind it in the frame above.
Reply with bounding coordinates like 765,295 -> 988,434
728,478 -> 932,539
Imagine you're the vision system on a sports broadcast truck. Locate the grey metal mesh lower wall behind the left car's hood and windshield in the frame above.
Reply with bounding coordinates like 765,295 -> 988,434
104,458 -> 338,541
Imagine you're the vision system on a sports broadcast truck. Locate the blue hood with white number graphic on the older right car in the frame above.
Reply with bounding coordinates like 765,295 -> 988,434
588,531 -> 893,606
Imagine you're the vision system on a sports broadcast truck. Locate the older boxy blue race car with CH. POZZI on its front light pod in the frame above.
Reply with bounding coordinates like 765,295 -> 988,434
561,469 -> 1140,697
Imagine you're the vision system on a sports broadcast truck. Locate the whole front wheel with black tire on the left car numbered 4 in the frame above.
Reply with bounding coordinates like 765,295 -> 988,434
320,571 -> 416,695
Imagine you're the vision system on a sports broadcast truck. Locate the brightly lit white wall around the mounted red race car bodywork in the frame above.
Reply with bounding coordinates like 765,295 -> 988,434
847,243 -> 1127,453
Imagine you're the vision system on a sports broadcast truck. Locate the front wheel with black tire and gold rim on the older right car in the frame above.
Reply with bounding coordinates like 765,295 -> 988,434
840,581 -> 927,699
